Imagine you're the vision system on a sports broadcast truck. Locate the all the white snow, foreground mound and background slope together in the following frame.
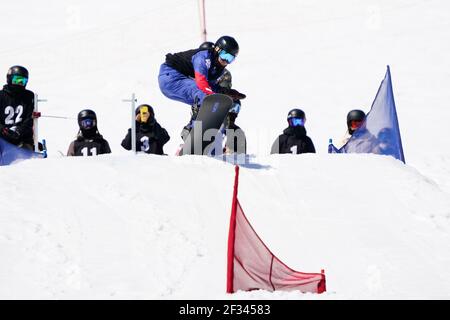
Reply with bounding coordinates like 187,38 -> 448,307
0,0 -> 450,299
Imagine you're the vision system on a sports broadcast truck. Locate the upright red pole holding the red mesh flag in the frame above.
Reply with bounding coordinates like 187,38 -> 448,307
227,165 -> 239,293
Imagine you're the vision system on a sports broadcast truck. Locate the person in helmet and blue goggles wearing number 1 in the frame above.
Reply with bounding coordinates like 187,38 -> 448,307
270,109 -> 316,154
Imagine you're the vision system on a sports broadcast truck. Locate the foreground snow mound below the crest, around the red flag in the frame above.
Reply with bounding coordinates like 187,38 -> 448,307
0,154 -> 450,299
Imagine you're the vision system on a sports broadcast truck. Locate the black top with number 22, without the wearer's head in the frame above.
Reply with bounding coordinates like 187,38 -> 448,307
0,85 -> 34,145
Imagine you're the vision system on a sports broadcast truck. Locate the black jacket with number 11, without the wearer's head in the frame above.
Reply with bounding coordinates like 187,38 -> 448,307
67,131 -> 111,157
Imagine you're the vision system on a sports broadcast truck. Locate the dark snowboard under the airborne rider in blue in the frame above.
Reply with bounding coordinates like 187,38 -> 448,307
179,93 -> 233,155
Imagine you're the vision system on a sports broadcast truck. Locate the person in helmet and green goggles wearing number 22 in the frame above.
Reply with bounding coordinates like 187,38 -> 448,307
0,66 -> 34,150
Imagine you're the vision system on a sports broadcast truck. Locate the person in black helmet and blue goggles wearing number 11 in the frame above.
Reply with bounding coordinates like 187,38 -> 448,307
67,109 -> 111,157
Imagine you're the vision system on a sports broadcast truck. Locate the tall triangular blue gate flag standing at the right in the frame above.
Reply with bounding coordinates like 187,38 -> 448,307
328,66 -> 405,162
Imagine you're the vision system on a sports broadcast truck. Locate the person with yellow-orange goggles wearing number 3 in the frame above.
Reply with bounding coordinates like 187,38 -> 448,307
122,104 -> 170,155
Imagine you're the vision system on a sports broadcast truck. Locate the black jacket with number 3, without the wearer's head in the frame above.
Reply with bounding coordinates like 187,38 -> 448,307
122,120 -> 170,155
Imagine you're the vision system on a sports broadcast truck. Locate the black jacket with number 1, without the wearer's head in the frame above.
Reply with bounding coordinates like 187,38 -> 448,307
270,127 -> 316,154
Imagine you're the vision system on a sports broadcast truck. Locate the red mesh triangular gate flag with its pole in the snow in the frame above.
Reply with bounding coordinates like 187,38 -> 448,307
227,166 -> 326,293
